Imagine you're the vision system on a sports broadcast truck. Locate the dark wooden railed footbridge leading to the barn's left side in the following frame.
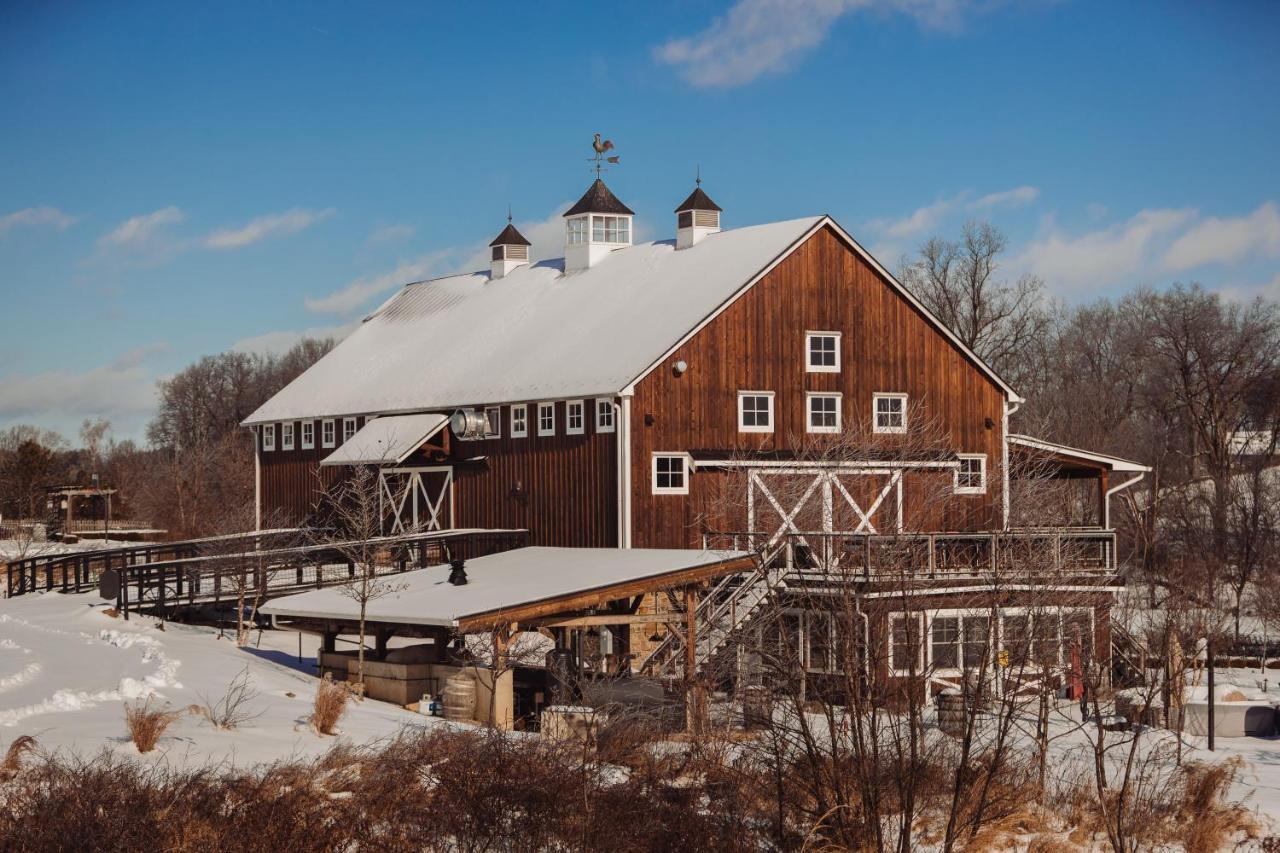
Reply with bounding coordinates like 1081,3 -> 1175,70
5,529 -> 529,617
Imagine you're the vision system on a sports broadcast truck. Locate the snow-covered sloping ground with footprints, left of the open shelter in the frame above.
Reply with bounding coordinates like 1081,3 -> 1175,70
0,593 -> 440,765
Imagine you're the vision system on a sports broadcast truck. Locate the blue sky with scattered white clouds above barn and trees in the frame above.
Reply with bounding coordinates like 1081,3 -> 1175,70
0,0 -> 1280,437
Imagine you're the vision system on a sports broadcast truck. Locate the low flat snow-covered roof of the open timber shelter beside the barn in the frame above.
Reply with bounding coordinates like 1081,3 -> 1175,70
261,548 -> 750,628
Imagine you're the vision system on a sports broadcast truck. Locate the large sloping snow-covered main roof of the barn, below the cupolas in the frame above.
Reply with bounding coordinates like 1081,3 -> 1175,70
244,216 -> 823,424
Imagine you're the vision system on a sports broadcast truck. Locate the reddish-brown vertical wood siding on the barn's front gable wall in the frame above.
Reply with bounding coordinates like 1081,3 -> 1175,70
631,222 -> 1005,547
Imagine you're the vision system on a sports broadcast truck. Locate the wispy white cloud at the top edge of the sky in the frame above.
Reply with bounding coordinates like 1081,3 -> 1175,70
654,0 -> 977,87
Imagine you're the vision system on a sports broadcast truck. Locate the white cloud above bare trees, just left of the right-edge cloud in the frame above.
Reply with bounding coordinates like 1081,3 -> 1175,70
1009,209 -> 1196,292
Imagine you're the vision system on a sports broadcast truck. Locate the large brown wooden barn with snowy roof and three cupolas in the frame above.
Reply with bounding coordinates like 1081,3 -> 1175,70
244,169 -> 1146,701
